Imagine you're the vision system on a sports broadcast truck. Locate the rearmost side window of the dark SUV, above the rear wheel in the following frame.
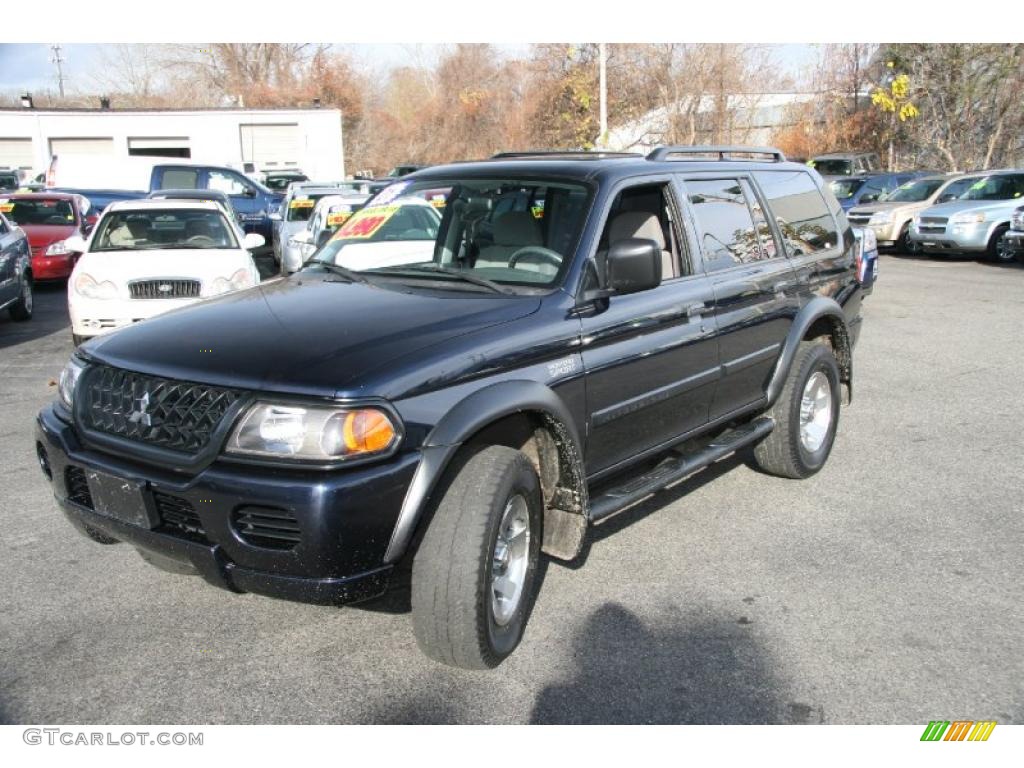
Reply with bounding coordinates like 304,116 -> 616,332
754,171 -> 840,256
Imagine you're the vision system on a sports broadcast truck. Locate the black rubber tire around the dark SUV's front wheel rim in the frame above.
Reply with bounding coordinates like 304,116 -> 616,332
412,445 -> 543,670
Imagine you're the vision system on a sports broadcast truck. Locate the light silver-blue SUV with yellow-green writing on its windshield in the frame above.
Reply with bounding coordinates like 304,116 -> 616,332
909,170 -> 1024,261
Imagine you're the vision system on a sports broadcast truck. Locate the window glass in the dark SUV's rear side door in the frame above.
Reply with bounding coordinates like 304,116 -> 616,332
686,178 -> 761,271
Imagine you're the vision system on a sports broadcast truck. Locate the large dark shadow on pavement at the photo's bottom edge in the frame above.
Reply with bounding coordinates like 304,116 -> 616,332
530,602 -> 824,724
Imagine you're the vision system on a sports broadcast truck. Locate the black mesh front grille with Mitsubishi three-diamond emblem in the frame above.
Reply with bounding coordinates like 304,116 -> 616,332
80,366 -> 242,454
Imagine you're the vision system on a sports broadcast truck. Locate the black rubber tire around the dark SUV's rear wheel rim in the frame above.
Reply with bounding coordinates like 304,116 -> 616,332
754,339 -> 840,479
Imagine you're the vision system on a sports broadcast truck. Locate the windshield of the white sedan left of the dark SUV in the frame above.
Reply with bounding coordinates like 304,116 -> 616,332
90,209 -> 239,252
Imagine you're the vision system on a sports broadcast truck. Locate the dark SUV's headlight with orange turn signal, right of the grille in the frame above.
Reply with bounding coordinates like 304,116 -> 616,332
227,402 -> 398,461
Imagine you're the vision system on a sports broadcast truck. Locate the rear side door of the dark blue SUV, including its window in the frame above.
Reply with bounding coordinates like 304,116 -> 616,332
684,173 -> 800,420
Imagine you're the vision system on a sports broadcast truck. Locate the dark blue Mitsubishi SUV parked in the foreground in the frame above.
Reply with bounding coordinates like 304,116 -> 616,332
35,147 -> 862,668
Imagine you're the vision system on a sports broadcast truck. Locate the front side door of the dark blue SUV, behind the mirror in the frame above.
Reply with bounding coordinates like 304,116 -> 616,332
581,178 -> 719,477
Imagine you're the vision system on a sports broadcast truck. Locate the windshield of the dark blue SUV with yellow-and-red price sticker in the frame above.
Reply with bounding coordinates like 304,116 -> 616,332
313,179 -> 590,290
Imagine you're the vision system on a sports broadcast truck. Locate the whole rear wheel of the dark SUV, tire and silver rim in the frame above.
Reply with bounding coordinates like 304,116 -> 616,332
754,339 -> 840,479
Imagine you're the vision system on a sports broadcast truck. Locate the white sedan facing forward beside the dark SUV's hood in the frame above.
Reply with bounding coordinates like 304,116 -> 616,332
67,200 -> 263,344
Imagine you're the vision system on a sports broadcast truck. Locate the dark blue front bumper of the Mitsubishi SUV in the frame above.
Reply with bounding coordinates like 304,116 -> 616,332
36,406 -> 419,604
